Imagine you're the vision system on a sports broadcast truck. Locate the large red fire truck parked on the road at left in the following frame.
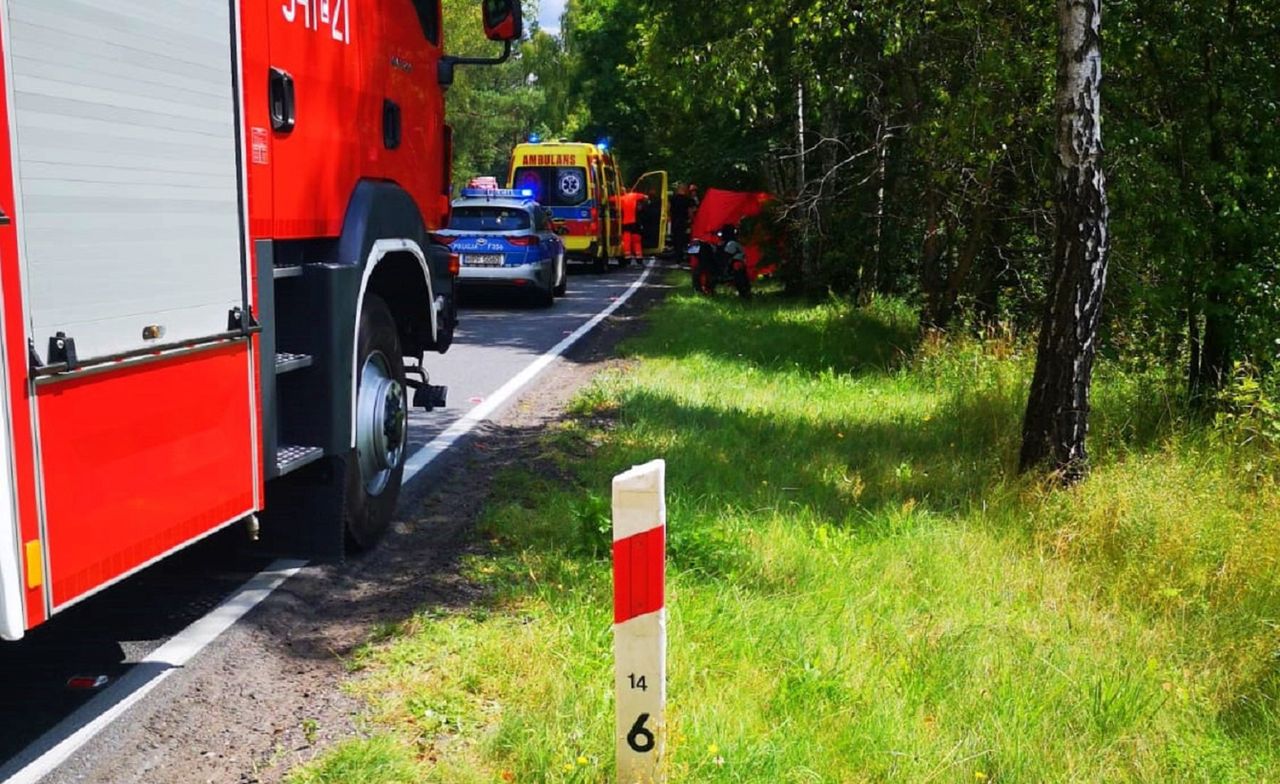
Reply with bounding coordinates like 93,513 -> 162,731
0,0 -> 522,639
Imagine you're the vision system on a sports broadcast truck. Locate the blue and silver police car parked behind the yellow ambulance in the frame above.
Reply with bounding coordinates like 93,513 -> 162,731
435,188 -> 568,307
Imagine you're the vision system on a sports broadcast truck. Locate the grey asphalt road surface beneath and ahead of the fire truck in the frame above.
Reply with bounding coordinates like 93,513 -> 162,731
0,261 -> 650,767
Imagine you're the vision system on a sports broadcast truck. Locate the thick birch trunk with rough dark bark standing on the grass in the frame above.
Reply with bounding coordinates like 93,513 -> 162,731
1021,0 -> 1110,483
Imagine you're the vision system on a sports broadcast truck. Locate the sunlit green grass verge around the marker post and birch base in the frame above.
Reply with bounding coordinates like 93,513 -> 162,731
294,281 -> 1280,784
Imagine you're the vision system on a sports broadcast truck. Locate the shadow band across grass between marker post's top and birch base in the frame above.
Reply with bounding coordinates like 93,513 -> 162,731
623,381 -> 1014,524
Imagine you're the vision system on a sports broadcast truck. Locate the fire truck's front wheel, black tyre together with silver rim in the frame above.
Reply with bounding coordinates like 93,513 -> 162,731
343,293 -> 408,550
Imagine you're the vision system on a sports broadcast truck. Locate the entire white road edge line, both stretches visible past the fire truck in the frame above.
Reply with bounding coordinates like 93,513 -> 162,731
0,264 -> 653,784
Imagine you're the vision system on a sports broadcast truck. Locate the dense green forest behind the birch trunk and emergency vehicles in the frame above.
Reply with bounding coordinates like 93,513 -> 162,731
445,0 -> 1280,402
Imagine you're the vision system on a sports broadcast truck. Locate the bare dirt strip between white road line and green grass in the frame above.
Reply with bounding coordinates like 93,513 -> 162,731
46,270 -> 668,784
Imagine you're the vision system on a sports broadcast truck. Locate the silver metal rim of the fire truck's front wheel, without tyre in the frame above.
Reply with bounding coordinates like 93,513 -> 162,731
356,351 -> 408,496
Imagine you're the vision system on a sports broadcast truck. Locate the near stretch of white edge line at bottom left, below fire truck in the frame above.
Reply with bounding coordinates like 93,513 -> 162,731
0,560 -> 306,784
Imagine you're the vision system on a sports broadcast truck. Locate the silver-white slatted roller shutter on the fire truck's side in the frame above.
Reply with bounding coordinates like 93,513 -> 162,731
5,0 -> 243,360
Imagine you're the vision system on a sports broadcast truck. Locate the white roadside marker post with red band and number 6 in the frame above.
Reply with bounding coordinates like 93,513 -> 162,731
613,460 -> 667,784
